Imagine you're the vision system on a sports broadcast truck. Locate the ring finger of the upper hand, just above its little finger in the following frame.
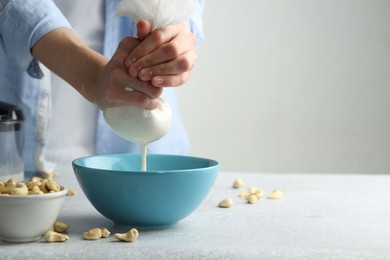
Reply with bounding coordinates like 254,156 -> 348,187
139,49 -> 197,81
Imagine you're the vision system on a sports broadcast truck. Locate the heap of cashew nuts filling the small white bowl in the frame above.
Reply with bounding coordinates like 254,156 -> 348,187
0,176 -> 64,195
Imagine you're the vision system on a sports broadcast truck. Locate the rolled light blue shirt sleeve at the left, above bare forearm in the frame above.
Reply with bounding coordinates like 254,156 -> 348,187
0,0 -> 71,78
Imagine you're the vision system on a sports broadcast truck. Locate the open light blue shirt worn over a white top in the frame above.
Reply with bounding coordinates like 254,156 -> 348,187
0,0 -> 204,175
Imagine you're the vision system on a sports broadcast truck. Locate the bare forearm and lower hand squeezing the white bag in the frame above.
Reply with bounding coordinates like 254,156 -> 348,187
31,28 -> 162,109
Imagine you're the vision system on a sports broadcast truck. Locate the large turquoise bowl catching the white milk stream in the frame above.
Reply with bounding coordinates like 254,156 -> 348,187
72,154 -> 220,228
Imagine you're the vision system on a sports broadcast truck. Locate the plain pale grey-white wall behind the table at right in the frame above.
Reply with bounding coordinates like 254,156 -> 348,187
178,0 -> 390,173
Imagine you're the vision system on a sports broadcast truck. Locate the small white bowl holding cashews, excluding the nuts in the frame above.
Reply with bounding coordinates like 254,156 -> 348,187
0,189 -> 67,242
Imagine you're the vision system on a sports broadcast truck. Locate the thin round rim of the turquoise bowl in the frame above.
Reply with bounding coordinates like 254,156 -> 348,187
72,153 -> 220,176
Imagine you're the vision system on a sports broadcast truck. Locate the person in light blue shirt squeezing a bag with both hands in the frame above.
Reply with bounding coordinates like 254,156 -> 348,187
0,0 -> 203,175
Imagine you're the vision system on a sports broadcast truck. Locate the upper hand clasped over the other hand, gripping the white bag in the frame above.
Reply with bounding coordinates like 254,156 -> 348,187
125,20 -> 197,87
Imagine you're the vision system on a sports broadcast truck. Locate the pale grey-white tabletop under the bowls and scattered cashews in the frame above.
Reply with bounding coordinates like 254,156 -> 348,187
0,165 -> 390,260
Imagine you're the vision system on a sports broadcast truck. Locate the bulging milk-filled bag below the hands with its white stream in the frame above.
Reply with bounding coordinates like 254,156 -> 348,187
103,99 -> 172,171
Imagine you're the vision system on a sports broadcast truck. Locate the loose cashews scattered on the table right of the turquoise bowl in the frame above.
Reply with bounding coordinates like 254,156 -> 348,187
218,179 -> 284,208
